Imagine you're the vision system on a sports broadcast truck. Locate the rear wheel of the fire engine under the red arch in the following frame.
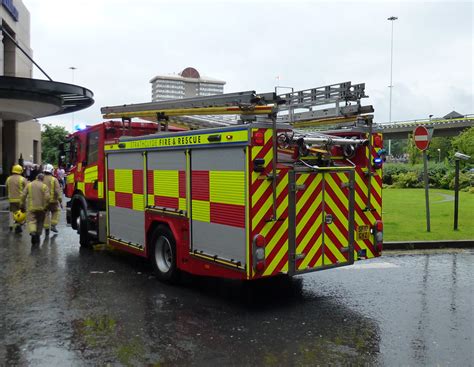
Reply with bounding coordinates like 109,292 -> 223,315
149,226 -> 179,283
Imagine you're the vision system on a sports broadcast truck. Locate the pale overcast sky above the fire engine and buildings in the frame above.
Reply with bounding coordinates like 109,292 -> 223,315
23,0 -> 474,132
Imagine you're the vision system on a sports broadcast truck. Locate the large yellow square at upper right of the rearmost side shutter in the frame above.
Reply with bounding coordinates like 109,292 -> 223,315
209,171 -> 245,205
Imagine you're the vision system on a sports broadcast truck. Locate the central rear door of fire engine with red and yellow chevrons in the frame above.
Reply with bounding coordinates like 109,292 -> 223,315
290,169 -> 354,273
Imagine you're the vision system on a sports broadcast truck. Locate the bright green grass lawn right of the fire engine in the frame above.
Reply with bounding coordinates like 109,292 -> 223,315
382,189 -> 474,242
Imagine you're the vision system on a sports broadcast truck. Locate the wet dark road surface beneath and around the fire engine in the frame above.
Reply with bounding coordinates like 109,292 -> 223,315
0,213 -> 474,366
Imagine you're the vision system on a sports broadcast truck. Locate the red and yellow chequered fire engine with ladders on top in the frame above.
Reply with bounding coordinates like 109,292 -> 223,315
62,82 -> 384,281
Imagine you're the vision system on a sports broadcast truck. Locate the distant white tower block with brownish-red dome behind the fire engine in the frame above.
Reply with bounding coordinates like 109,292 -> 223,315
150,67 -> 225,102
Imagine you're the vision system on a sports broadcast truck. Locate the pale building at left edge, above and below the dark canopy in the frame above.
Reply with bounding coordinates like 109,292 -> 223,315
0,0 -> 41,183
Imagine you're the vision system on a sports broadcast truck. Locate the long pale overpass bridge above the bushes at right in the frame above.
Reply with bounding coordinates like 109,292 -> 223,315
376,114 -> 474,140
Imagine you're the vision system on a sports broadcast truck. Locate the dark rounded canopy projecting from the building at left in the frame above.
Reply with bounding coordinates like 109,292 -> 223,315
0,76 -> 94,122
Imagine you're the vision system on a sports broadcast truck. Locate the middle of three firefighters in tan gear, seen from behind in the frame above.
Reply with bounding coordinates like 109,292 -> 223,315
21,173 -> 49,245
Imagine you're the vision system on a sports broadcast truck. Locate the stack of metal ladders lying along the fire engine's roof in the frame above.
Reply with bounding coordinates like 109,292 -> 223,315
101,82 -> 373,129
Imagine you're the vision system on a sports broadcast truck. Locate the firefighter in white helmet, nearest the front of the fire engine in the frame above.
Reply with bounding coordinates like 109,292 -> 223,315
43,164 -> 63,235
